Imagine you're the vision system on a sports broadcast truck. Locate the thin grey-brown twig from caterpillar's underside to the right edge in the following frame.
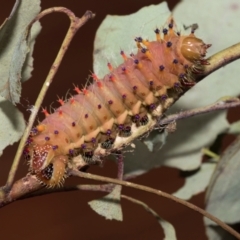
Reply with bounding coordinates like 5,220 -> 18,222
158,98 -> 240,125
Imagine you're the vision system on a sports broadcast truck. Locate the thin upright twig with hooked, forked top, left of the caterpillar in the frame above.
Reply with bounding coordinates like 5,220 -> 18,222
4,7 -> 94,192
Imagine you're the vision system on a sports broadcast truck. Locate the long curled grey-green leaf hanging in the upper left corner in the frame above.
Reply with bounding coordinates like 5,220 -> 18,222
0,0 -> 41,104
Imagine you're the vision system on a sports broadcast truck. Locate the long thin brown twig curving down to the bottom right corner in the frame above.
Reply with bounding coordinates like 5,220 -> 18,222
70,169 -> 240,239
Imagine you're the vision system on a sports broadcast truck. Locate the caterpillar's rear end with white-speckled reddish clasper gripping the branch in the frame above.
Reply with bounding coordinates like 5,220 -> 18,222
29,144 -> 67,187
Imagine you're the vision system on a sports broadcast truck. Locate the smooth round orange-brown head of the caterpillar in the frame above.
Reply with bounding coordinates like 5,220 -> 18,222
181,35 -> 211,62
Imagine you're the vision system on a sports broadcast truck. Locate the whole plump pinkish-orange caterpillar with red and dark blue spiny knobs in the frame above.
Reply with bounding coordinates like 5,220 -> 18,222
24,17 -> 211,187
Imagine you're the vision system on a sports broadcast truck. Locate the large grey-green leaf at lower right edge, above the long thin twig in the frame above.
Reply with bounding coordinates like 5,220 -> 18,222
205,137 -> 240,225
